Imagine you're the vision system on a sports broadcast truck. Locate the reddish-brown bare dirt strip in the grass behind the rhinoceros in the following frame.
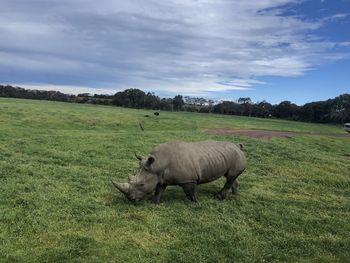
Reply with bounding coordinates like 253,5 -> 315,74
207,128 -> 350,139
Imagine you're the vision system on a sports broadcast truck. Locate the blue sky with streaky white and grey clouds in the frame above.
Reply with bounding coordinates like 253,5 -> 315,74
0,0 -> 350,104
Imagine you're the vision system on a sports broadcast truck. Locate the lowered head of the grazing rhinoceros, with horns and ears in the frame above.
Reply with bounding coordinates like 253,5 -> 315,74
112,156 -> 158,202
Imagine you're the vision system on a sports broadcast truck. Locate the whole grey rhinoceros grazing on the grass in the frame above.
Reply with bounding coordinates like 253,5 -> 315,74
112,140 -> 246,203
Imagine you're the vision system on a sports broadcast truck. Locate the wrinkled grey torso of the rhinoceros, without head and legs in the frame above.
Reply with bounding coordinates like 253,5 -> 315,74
151,141 -> 245,184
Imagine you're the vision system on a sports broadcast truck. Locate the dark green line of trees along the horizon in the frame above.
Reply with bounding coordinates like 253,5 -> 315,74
0,85 -> 350,123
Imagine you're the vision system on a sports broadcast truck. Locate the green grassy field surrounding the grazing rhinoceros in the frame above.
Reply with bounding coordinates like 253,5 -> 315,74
0,98 -> 350,262
